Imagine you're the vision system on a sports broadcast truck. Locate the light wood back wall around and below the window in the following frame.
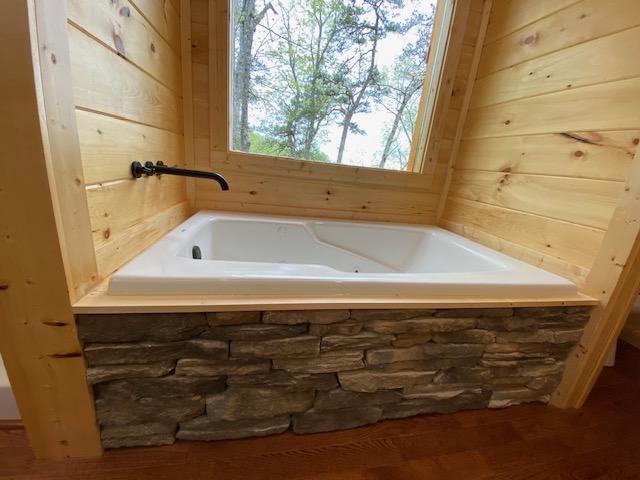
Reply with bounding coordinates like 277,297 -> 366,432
191,0 -> 484,224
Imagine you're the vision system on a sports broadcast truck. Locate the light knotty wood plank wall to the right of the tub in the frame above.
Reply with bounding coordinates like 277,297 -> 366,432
440,0 -> 640,284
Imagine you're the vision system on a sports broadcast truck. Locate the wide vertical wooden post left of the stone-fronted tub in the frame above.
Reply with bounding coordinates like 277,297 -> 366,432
0,0 -> 101,459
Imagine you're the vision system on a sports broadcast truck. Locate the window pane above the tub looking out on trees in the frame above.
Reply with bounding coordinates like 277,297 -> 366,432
230,0 -> 452,170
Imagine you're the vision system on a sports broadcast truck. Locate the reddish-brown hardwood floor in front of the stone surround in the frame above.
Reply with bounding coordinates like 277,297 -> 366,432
0,344 -> 640,480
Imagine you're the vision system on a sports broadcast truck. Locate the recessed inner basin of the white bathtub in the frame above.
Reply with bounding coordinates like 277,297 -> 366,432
178,219 -> 506,273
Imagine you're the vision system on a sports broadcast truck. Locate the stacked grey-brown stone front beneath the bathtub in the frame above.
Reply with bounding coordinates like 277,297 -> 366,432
78,307 -> 590,448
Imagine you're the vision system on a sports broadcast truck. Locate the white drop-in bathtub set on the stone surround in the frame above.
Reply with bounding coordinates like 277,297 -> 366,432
108,211 -> 577,298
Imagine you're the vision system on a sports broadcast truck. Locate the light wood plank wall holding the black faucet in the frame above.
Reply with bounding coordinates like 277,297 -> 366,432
66,0 -> 189,277
